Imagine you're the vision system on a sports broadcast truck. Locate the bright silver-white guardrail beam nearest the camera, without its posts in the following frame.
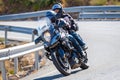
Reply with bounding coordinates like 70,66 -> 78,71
0,42 -> 43,61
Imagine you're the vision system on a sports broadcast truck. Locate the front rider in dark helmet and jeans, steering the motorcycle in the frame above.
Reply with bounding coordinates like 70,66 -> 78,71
46,11 -> 86,68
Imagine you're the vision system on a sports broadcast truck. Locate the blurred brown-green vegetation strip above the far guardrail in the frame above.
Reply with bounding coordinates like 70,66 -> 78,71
0,0 -> 120,15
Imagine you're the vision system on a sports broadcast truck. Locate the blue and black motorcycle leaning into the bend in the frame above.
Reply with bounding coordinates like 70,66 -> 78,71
34,17 -> 88,76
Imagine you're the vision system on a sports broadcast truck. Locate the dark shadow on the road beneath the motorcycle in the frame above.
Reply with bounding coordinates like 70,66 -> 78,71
34,70 -> 82,80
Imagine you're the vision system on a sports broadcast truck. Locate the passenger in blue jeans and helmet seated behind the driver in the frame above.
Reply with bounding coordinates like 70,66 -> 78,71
52,3 -> 88,57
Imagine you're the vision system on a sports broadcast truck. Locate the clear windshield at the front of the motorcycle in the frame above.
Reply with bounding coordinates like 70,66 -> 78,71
37,17 -> 51,36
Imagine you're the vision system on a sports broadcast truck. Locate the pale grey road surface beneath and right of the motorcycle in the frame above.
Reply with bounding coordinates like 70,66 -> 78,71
0,21 -> 120,80
